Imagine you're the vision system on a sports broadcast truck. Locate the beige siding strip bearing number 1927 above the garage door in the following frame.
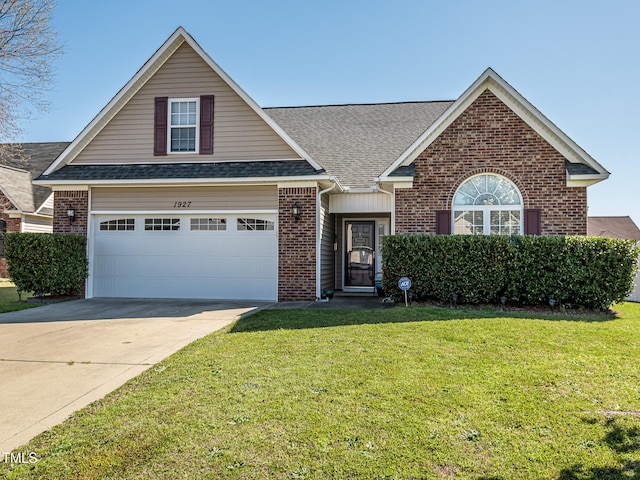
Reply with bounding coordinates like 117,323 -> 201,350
91,185 -> 278,213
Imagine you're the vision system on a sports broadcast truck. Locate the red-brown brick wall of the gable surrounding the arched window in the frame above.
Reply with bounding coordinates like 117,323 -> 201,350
395,90 -> 587,235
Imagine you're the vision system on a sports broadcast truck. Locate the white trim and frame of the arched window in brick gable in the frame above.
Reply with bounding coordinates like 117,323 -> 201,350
451,172 -> 524,235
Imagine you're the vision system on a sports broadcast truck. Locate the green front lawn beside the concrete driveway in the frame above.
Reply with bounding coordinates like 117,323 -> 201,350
0,303 -> 640,480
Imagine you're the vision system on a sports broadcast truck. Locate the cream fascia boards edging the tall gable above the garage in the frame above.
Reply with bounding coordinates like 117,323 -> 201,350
43,27 -> 322,175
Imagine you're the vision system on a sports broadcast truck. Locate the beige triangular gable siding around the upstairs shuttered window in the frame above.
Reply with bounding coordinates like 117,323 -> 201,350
73,43 -> 300,164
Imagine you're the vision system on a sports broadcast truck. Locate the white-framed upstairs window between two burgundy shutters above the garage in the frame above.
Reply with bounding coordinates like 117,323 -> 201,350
168,98 -> 200,153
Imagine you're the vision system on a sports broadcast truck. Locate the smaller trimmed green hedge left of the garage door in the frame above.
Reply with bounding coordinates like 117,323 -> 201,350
4,233 -> 88,295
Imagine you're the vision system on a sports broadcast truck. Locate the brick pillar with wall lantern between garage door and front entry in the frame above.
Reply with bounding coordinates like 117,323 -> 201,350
278,187 -> 316,302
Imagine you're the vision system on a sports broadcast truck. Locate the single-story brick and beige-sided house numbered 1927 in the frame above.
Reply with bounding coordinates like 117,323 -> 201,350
36,28 -> 609,301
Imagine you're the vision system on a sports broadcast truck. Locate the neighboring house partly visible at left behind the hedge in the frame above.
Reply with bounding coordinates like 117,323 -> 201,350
0,142 -> 69,277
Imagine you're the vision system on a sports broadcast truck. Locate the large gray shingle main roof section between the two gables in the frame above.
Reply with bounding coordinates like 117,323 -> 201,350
264,101 -> 453,188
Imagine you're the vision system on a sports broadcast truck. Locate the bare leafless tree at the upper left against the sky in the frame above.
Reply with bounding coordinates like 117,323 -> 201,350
0,0 -> 62,148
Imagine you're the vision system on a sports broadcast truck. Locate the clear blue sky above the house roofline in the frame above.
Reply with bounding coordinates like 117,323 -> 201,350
21,0 -> 640,226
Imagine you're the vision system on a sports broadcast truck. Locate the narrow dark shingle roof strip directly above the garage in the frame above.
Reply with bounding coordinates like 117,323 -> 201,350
38,160 -> 322,181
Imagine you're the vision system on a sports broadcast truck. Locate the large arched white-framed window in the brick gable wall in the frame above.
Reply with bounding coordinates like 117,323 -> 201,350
452,173 -> 523,235
